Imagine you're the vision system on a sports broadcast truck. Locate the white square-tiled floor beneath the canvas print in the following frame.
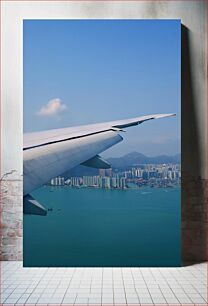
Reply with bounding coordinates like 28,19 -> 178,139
0,262 -> 207,306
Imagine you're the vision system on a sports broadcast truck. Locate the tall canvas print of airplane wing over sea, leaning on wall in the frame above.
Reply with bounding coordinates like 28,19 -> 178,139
23,20 -> 181,267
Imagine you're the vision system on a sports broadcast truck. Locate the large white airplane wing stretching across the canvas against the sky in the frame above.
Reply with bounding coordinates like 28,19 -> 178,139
23,114 -> 175,216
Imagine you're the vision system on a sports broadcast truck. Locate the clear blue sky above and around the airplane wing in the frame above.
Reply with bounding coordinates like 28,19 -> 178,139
23,20 -> 181,157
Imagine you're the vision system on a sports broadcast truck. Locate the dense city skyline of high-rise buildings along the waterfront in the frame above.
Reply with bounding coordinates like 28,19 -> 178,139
49,163 -> 181,189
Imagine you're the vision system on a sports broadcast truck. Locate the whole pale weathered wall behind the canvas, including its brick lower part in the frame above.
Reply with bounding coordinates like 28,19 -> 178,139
0,0 -> 208,260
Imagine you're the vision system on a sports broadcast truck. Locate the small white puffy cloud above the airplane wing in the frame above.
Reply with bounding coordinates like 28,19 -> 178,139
37,98 -> 67,117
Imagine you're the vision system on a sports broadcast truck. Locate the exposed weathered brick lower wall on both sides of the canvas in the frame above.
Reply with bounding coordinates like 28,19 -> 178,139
0,174 -> 208,263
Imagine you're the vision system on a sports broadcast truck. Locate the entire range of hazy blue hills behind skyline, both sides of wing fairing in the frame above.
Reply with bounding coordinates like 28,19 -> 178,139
64,152 -> 181,177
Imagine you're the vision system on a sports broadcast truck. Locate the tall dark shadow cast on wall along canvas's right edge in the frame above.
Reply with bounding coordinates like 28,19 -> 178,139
181,25 -> 208,265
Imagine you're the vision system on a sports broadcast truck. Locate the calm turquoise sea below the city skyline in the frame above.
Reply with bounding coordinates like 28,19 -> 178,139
23,186 -> 181,267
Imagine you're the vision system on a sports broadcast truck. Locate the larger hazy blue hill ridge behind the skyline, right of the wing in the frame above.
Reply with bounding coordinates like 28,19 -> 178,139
108,152 -> 181,168
